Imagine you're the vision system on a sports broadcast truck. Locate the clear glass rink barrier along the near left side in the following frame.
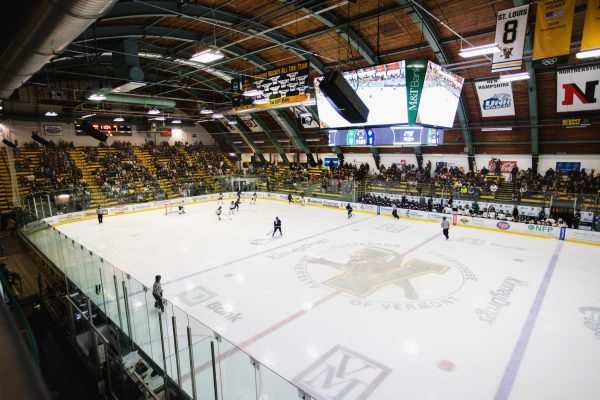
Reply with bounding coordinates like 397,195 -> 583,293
21,209 -> 310,400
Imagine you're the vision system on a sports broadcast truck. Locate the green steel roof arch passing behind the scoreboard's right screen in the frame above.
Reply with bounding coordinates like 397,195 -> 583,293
396,0 -> 474,157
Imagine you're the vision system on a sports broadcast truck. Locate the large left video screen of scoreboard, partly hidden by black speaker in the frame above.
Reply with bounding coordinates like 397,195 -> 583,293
314,61 -> 408,129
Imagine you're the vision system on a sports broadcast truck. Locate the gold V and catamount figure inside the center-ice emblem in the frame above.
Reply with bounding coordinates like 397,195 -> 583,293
309,246 -> 449,300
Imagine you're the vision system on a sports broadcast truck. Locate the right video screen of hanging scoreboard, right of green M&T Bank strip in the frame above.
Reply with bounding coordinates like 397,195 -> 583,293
416,61 -> 464,128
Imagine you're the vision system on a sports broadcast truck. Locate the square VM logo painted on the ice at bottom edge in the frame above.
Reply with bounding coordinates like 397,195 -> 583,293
293,346 -> 391,400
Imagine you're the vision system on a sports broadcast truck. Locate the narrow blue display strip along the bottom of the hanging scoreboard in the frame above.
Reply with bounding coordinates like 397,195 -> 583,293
329,126 -> 444,146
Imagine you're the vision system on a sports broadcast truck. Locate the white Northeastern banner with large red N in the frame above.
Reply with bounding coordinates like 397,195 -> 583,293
556,64 -> 600,112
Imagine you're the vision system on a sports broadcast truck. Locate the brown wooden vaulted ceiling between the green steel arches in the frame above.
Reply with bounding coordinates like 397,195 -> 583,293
32,0 -> 600,153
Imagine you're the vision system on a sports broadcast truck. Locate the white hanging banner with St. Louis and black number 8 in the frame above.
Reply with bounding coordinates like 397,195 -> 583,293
492,5 -> 529,72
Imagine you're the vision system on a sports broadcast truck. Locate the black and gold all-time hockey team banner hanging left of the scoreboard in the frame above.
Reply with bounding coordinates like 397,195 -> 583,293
231,61 -> 312,111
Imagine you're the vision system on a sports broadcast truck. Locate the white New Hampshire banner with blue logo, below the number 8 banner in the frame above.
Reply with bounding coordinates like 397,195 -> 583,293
475,78 -> 521,118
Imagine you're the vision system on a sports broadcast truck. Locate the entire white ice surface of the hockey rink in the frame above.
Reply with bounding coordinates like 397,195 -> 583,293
58,199 -> 600,400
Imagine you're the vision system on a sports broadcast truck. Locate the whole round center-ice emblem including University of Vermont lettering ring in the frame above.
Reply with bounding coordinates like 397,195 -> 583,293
295,243 -> 470,310
